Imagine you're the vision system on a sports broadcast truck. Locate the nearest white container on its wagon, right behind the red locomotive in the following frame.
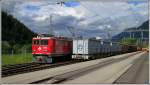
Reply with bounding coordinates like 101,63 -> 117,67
72,39 -> 101,59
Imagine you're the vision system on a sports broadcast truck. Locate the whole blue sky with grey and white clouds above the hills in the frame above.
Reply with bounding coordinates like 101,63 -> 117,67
2,0 -> 148,38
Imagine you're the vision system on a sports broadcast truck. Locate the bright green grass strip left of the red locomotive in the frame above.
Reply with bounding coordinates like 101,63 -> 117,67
2,53 -> 32,65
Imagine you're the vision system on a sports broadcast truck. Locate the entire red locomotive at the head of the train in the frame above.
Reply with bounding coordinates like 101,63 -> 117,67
32,37 -> 72,63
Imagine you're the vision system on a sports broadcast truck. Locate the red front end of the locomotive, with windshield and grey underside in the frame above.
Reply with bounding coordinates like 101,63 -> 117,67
32,37 -> 54,63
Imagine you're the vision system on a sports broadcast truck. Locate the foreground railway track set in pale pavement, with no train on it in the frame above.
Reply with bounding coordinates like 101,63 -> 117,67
30,51 -> 141,84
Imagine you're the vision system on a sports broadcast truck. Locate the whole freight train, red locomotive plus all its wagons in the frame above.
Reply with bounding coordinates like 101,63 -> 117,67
32,37 -> 137,63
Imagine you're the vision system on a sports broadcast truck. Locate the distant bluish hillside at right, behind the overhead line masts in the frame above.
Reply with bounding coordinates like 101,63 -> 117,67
112,21 -> 149,40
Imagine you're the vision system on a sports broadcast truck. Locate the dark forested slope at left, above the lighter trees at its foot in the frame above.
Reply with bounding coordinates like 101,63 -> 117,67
2,12 -> 37,45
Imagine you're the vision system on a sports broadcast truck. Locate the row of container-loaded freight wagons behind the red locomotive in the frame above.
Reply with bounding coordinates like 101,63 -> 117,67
72,39 -> 137,60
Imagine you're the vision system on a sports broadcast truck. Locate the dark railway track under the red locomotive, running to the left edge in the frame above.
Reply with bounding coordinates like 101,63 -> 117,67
2,60 -> 82,77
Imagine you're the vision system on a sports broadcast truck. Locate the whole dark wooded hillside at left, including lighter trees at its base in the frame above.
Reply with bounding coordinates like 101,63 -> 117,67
2,12 -> 37,52
